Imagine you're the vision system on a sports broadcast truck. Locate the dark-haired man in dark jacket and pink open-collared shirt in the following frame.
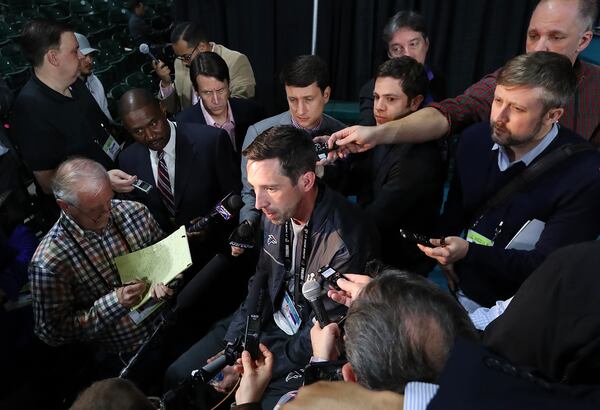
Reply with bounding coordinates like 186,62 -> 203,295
175,51 -> 264,158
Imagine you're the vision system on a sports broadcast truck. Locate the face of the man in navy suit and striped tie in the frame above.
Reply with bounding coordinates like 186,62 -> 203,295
123,104 -> 171,151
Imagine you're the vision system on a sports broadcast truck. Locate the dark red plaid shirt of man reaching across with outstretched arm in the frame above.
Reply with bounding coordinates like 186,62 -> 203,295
429,60 -> 600,145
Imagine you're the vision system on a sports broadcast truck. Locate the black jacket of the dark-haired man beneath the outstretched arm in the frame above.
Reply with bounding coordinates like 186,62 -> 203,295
344,142 -> 445,274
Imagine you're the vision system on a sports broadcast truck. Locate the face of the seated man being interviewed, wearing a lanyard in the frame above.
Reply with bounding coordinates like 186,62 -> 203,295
247,158 -> 304,225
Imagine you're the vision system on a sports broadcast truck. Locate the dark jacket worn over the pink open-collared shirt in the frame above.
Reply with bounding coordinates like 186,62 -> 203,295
175,97 -> 264,156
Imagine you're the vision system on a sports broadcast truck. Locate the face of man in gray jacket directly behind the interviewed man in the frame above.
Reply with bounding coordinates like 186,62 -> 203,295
285,82 -> 331,128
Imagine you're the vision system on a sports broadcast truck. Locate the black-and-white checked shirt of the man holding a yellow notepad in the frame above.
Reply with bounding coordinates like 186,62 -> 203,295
29,200 -> 164,352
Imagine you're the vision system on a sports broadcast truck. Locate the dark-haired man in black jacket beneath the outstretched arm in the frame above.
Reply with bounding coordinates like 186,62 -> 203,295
344,56 -> 445,274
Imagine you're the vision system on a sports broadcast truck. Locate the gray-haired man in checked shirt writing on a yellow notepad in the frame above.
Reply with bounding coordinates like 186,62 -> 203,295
29,158 -> 172,353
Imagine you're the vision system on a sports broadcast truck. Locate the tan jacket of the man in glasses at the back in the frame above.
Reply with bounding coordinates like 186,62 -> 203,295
159,43 -> 256,114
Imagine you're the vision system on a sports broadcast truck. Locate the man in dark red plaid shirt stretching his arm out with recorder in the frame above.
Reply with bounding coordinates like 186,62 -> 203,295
330,0 -> 600,152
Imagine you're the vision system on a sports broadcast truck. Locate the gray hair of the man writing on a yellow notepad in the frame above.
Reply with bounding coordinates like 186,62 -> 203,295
52,157 -> 110,206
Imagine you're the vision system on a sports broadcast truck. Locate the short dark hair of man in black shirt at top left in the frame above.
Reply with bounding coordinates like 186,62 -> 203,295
20,19 -> 75,67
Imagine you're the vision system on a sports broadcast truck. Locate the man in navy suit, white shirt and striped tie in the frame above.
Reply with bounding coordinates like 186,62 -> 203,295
119,89 -> 240,262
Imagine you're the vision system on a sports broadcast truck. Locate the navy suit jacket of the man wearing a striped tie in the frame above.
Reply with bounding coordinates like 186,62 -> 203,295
119,124 -> 240,232
